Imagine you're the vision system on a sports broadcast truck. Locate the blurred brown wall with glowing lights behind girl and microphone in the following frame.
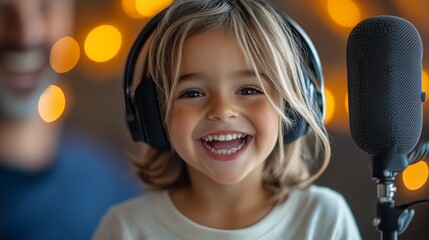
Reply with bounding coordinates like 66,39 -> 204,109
47,0 -> 429,239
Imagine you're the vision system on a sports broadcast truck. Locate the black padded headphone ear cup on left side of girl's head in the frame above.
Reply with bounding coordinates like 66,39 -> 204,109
134,78 -> 170,151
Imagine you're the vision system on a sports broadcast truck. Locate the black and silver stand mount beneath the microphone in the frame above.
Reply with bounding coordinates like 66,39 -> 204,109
372,150 -> 414,240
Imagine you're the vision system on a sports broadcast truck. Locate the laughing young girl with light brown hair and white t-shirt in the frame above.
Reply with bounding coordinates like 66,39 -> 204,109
94,0 -> 360,240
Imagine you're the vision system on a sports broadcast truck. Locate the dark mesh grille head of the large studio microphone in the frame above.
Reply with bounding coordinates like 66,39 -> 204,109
347,16 -> 423,154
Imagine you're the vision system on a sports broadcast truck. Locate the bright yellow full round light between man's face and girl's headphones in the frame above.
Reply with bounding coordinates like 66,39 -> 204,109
85,25 -> 122,62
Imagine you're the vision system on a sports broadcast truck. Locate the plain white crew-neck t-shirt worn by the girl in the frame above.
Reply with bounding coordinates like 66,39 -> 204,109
93,186 -> 361,240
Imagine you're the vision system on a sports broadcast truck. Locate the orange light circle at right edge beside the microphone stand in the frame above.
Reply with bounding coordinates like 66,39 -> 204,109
402,161 -> 429,190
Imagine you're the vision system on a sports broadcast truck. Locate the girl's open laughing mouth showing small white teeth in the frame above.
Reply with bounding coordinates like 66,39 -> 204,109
200,133 -> 252,160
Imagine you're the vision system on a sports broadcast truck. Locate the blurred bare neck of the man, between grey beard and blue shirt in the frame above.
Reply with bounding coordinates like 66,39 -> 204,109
0,116 -> 59,170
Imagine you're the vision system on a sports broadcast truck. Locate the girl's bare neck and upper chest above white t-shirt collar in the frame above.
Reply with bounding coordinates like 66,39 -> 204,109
171,165 -> 274,229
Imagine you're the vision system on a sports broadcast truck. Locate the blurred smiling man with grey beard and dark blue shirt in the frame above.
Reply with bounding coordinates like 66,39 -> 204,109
0,0 -> 140,240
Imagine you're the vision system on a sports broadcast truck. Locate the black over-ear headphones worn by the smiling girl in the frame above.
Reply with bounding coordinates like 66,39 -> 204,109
124,7 -> 325,151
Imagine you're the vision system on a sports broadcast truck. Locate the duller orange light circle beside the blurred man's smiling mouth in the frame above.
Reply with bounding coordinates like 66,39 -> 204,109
49,37 -> 80,73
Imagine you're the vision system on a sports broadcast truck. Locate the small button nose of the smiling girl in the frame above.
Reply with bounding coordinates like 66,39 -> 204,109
207,96 -> 240,121
